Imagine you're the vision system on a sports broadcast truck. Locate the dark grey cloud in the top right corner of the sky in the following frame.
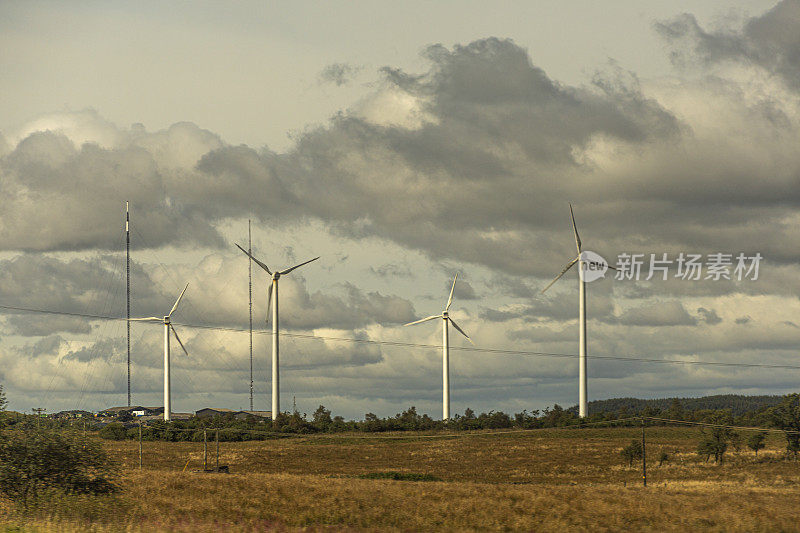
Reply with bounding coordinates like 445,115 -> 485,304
656,0 -> 800,88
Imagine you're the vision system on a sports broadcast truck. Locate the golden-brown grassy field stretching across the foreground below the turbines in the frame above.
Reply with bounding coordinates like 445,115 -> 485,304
2,428 -> 800,531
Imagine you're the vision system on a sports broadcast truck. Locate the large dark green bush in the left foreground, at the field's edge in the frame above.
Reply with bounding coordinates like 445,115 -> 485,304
0,431 -> 118,501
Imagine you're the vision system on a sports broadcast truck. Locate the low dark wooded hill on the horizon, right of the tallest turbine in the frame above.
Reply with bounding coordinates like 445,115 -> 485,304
568,394 -> 783,416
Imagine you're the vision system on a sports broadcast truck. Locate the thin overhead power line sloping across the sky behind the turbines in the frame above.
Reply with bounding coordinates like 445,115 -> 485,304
0,305 -> 800,370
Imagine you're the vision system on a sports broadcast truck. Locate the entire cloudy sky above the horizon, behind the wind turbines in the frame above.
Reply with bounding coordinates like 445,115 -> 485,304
0,0 -> 800,418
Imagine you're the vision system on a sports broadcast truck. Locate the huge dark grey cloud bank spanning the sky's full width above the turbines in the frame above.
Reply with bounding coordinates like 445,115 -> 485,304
0,34 -> 800,294
